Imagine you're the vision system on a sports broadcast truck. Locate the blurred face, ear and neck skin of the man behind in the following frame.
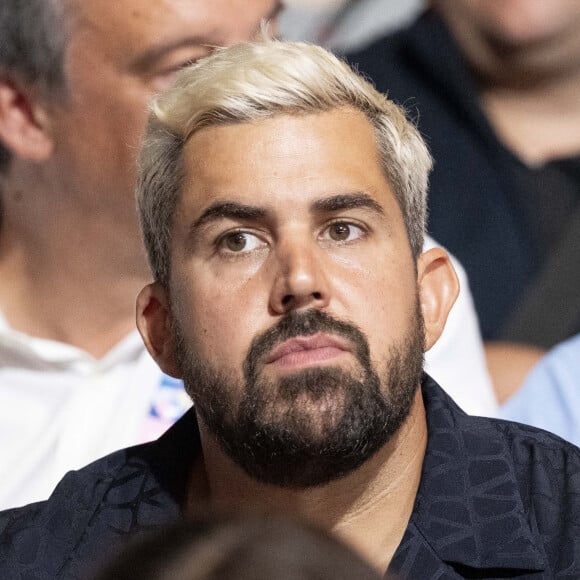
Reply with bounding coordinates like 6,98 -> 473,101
0,0 -> 279,356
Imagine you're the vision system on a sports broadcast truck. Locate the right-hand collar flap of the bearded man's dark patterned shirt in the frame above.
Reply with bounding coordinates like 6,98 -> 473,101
410,376 -> 546,570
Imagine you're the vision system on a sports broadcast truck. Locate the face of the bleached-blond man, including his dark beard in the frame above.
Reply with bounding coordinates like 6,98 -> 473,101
156,110 -> 432,486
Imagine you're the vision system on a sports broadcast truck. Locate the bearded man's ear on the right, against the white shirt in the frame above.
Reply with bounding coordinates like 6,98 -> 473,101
417,248 -> 459,350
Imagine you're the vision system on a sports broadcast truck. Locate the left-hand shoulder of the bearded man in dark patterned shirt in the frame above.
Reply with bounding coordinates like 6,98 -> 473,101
0,422 -> 187,580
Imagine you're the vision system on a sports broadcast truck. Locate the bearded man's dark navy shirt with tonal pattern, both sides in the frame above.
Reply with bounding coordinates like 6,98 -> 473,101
0,377 -> 580,580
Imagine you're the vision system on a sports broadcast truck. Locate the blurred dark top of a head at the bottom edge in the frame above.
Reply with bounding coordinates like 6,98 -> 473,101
97,515 -> 380,580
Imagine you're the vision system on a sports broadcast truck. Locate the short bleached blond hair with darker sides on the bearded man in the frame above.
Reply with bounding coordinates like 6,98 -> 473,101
136,40 -> 432,287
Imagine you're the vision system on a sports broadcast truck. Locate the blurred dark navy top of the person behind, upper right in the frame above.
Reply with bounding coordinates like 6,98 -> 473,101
348,11 -> 580,348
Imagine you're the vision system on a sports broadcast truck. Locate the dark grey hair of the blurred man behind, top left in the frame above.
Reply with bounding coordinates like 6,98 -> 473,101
0,0 -> 67,173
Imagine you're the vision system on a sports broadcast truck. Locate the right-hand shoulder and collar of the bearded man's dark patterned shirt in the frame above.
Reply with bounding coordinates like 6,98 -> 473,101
413,381 -> 580,578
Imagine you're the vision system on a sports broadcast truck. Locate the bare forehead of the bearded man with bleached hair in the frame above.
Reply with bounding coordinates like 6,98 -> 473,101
181,109 -> 398,214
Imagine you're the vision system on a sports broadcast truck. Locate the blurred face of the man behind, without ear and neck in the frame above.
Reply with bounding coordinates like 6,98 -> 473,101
46,0 -> 279,250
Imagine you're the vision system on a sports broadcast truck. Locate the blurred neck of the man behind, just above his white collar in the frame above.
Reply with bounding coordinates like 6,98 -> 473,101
0,177 -> 149,358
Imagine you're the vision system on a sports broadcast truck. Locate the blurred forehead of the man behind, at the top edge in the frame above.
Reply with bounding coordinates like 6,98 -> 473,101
67,0 -> 278,48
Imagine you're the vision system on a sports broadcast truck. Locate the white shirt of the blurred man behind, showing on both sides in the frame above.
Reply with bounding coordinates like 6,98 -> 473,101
0,240 -> 497,509
